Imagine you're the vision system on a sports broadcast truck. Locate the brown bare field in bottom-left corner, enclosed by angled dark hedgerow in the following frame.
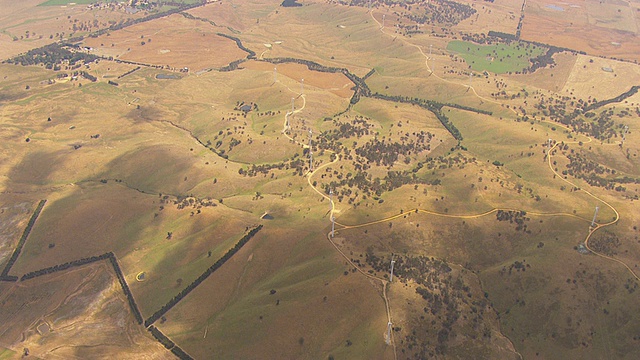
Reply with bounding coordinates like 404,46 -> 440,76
0,262 -> 173,359
